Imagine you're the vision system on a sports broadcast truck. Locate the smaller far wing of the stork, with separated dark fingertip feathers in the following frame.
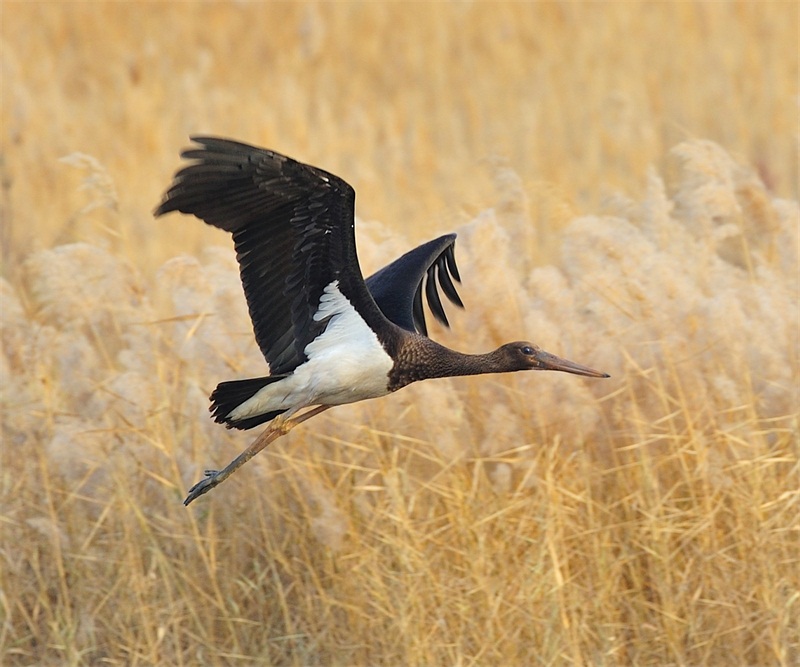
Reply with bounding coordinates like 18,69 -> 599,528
367,234 -> 464,336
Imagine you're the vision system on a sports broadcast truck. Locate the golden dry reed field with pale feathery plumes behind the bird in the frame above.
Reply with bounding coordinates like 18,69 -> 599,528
0,2 -> 800,666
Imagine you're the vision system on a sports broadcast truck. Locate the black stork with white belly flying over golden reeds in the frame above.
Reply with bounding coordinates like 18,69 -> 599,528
155,137 -> 609,505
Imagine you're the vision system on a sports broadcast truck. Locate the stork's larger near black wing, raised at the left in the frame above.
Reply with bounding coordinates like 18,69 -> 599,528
155,137 -> 385,375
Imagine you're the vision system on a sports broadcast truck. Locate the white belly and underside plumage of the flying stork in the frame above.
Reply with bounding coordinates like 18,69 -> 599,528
227,280 -> 393,419
